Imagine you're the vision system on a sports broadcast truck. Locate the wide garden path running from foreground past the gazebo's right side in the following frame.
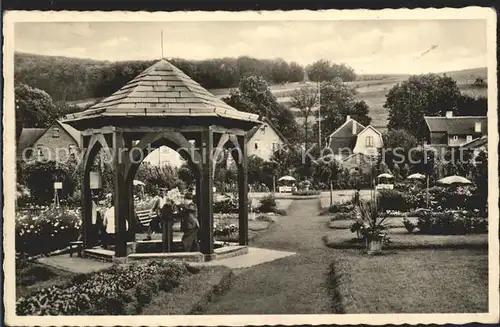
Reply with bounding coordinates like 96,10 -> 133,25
199,199 -> 336,314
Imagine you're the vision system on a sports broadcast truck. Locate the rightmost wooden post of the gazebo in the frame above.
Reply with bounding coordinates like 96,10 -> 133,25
237,136 -> 248,245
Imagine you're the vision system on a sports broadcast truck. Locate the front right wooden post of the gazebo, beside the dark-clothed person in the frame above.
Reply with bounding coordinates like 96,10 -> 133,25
198,128 -> 214,255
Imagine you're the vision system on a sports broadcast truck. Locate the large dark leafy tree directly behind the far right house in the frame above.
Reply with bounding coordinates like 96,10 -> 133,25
384,74 -> 460,140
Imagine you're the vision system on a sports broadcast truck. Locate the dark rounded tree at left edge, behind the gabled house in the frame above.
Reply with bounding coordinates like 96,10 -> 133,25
14,84 -> 59,138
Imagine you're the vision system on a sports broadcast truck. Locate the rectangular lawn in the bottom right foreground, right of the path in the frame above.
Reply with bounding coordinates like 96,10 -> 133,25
330,249 -> 488,313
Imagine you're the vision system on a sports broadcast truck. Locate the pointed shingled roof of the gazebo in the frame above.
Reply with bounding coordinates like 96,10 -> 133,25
65,60 -> 258,129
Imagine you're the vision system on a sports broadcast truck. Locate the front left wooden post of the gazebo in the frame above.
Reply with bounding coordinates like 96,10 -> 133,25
113,132 -> 130,257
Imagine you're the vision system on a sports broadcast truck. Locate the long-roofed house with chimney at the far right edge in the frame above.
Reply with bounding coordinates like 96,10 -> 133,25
425,111 -> 488,148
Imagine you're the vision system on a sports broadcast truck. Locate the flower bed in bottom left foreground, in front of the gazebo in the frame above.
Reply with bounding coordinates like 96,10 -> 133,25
16,261 -> 197,315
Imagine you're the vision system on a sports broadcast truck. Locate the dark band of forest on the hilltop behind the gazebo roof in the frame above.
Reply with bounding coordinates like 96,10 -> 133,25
14,53 -> 304,101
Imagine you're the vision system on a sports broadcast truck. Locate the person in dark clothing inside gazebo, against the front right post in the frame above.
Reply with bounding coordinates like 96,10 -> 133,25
181,193 -> 200,252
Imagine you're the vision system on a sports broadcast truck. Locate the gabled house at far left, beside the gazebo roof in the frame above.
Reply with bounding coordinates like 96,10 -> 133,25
16,121 -> 80,161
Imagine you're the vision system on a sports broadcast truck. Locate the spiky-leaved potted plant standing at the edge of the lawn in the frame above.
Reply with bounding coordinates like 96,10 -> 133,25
351,201 -> 388,254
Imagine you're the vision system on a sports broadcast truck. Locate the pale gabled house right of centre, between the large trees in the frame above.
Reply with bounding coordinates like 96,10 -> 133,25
328,116 -> 384,161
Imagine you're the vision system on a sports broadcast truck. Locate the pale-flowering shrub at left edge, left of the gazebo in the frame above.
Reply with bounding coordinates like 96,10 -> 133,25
16,208 -> 81,256
